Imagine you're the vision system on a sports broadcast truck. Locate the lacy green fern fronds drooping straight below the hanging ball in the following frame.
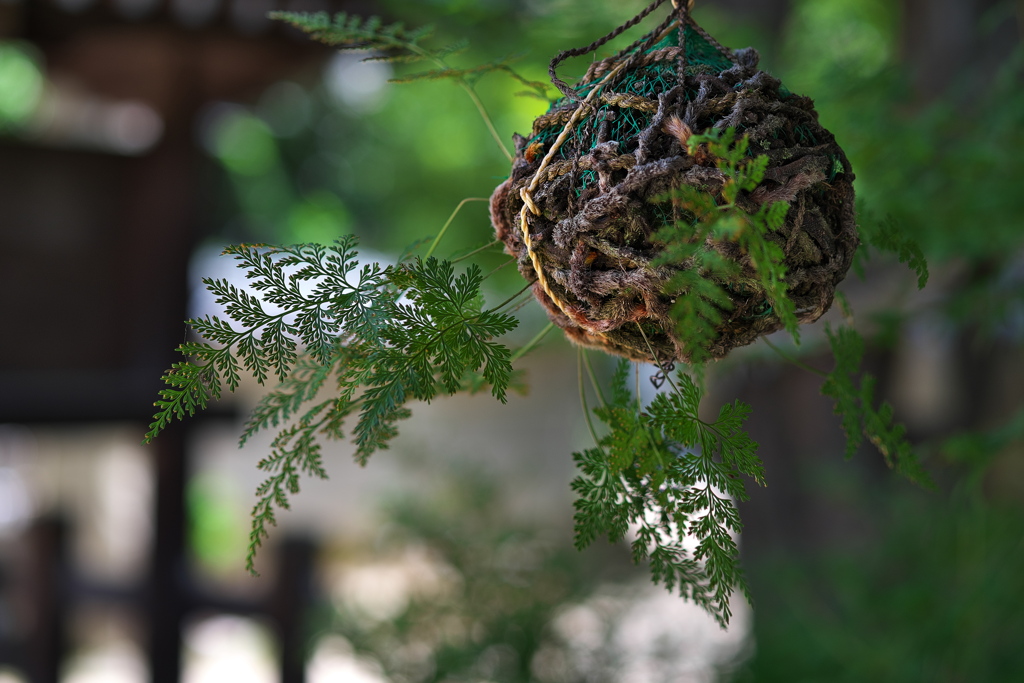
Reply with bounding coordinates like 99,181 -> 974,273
572,361 -> 764,626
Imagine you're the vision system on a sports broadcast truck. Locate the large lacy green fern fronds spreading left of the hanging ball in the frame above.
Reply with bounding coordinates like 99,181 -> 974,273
145,237 -> 517,568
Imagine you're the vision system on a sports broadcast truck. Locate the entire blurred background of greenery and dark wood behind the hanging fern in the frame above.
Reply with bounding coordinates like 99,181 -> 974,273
0,0 -> 1024,683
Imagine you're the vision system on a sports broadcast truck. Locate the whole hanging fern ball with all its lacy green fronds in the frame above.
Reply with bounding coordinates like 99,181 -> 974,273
146,0 -> 927,625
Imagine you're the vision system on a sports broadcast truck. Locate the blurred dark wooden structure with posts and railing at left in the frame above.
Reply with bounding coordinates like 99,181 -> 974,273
0,0 -> 371,683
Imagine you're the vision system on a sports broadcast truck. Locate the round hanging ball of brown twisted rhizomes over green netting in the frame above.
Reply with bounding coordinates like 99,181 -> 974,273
490,17 -> 858,364
